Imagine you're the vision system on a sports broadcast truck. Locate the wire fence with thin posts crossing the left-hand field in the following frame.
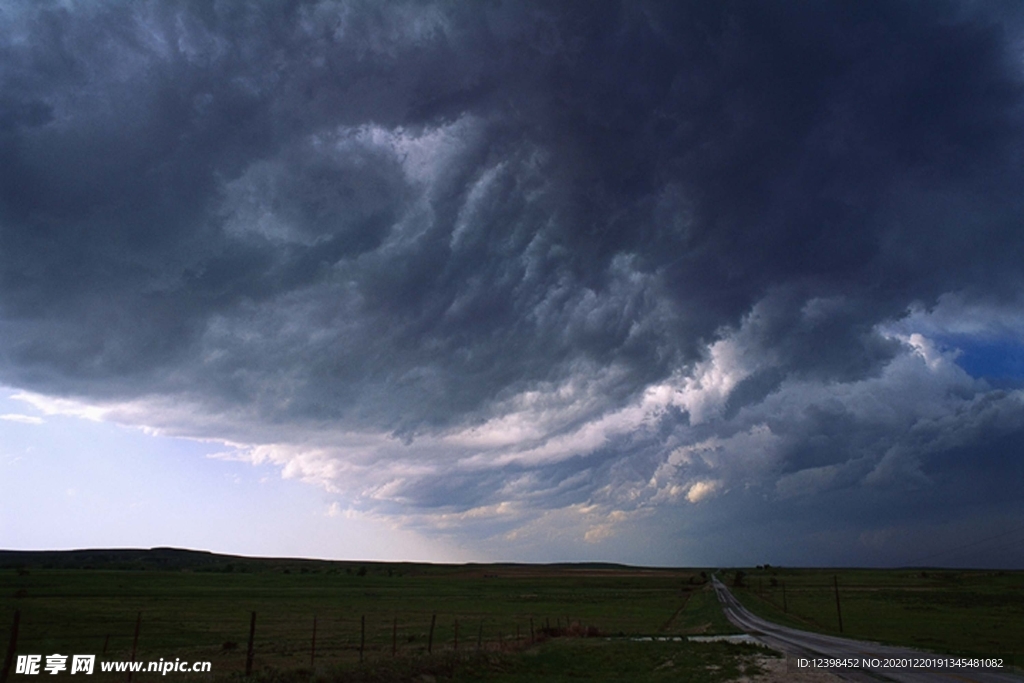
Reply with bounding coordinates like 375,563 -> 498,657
0,609 -> 600,683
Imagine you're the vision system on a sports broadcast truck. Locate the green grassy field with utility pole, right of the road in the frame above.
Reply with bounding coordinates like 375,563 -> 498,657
719,567 -> 1024,666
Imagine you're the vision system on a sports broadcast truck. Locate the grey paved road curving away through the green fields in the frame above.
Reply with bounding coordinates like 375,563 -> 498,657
712,578 -> 1024,683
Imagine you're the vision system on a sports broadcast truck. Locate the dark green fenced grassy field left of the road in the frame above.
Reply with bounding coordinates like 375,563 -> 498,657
0,561 -> 742,681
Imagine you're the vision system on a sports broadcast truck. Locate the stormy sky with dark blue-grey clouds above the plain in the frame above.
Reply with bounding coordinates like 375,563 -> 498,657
0,0 -> 1024,568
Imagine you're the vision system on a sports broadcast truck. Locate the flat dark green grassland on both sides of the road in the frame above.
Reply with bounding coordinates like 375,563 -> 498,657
0,549 -> 1024,683
